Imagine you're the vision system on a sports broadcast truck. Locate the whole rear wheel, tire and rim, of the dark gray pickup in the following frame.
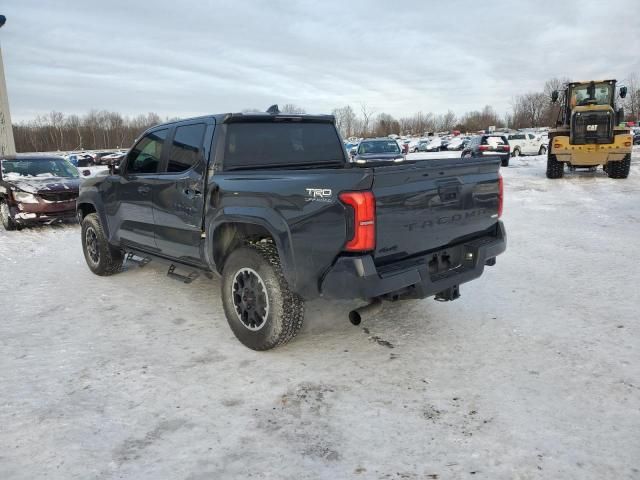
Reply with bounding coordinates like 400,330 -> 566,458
222,241 -> 304,350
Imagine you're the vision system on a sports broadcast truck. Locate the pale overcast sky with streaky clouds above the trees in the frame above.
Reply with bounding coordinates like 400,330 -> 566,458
0,0 -> 640,121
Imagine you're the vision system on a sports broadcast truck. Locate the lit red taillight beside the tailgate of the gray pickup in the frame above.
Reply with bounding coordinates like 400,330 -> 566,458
339,192 -> 376,252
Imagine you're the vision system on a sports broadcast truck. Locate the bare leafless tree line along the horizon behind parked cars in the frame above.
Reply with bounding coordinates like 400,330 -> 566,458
13,74 -> 640,152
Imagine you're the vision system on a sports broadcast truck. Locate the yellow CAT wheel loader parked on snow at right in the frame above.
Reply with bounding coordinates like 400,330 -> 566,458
547,80 -> 633,178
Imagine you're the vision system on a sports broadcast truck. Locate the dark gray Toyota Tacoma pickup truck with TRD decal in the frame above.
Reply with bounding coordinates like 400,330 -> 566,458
77,109 -> 506,350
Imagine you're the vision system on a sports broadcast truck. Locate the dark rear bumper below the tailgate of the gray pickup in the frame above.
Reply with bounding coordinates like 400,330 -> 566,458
320,222 -> 507,299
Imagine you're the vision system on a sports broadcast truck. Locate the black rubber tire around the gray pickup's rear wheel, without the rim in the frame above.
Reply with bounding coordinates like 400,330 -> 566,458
222,241 -> 304,350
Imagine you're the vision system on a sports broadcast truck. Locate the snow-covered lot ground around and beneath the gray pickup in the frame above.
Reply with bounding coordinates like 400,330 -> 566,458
0,151 -> 640,480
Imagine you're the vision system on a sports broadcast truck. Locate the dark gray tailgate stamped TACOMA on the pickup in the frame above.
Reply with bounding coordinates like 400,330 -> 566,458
372,158 -> 500,265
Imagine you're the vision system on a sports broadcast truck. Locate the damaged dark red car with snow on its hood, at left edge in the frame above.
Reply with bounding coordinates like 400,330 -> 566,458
0,154 -> 80,230
